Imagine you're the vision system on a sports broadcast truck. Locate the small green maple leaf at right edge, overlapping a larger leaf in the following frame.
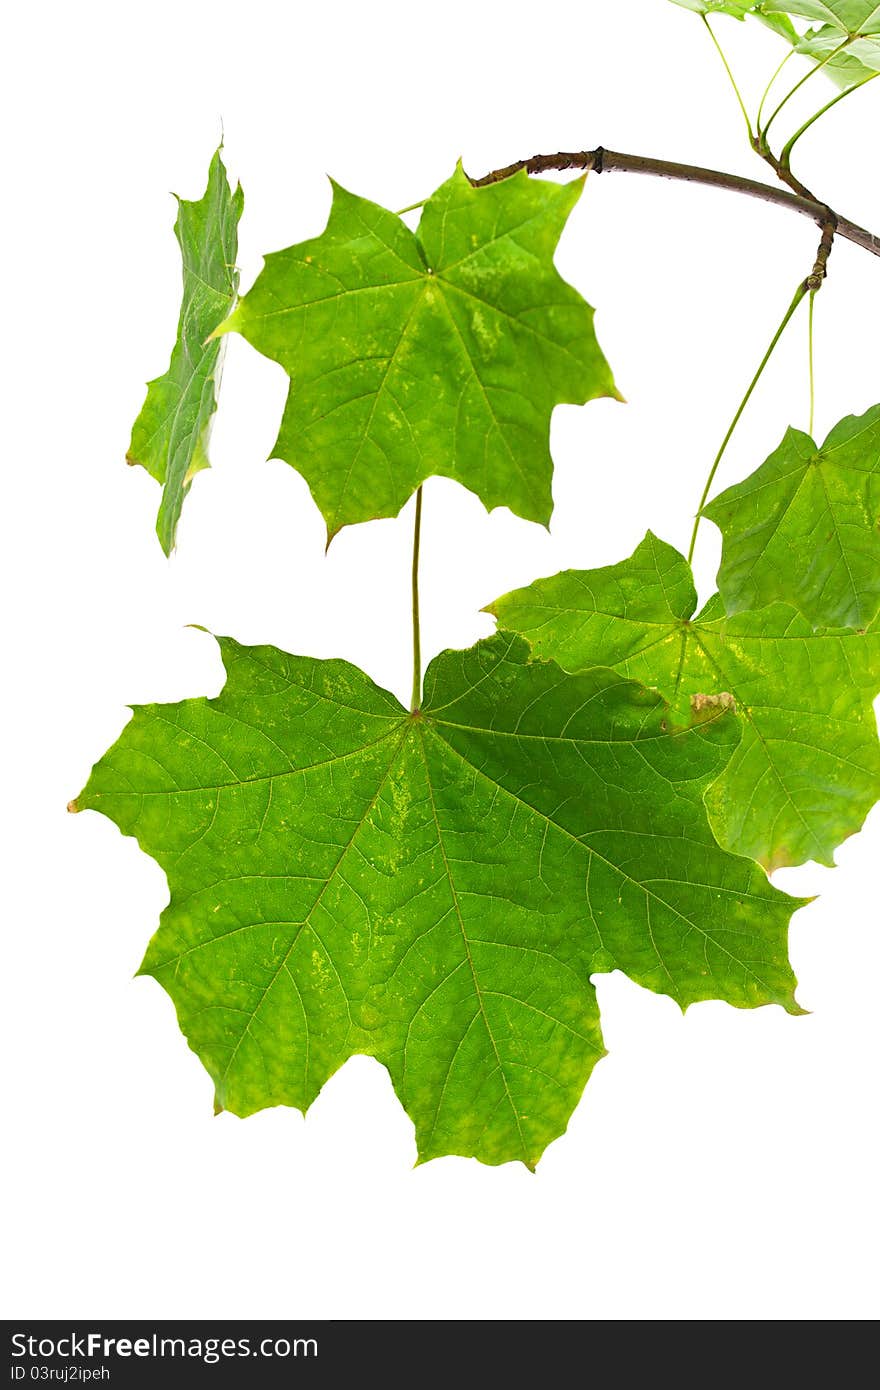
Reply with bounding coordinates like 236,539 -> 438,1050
702,406 -> 880,628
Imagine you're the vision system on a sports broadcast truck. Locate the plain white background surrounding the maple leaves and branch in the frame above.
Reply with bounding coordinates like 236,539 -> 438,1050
0,0 -> 880,1319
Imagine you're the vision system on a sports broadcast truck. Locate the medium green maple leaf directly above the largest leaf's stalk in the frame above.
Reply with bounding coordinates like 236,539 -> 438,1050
220,167 -> 617,538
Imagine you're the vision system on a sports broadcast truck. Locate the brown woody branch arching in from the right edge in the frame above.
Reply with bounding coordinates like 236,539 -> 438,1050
471,146 -> 880,261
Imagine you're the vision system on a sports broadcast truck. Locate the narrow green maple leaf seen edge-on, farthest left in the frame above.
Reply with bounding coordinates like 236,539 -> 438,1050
127,150 -> 245,555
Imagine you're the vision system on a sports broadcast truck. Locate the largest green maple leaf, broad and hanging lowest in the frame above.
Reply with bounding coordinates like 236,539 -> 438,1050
74,635 -> 799,1166
